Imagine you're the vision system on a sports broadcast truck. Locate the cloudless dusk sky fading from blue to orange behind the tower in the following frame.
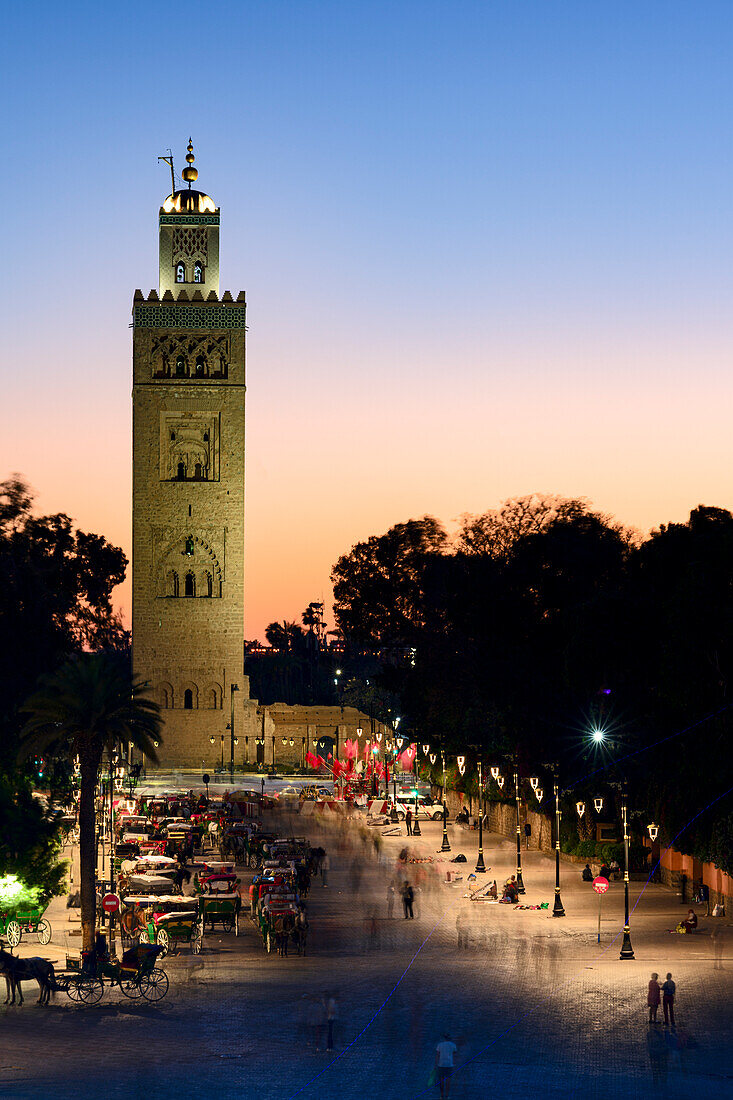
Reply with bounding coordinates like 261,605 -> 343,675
0,0 -> 733,638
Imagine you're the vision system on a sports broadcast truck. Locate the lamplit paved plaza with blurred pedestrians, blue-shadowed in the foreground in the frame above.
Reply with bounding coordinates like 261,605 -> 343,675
0,814 -> 733,1100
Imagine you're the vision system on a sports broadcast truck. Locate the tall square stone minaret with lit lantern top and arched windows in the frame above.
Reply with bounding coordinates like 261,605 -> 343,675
132,141 -> 249,768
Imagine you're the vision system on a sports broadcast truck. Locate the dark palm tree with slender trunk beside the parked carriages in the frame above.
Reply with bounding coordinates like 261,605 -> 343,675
20,652 -> 161,950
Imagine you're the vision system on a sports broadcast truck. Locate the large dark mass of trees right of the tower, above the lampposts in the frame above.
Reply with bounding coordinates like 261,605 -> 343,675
331,494 -> 733,862
